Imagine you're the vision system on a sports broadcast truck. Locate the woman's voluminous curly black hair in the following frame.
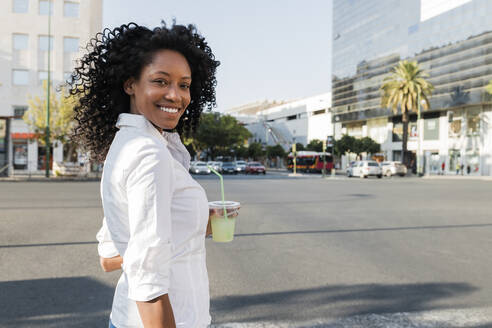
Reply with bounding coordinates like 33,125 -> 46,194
68,21 -> 220,162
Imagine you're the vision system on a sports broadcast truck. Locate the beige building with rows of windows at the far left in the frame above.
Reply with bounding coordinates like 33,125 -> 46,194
0,0 -> 102,173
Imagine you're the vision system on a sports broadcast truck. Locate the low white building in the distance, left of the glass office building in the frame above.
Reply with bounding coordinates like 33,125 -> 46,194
232,93 -> 333,149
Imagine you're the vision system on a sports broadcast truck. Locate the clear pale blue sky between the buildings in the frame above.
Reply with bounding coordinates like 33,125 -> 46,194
103,0 -> 332,111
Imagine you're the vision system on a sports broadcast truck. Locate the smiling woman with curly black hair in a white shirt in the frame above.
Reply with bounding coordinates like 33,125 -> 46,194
70,23 -> 219,328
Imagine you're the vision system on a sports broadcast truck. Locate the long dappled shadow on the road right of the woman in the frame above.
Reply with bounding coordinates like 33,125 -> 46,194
211,283 -> 477,324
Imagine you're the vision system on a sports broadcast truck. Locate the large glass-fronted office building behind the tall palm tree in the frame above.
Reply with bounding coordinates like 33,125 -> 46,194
332,0 -> 492,175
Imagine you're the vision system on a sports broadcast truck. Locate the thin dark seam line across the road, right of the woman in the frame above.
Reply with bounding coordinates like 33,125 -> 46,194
234,223 -> 492,238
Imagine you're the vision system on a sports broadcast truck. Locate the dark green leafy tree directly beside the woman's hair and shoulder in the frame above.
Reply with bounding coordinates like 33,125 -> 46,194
192,112 -> 251,159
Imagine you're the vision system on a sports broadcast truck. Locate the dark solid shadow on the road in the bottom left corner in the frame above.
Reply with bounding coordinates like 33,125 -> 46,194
0,277 -> 114,328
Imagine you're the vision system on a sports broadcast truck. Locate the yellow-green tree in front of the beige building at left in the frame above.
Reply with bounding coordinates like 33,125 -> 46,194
22,81 -> 78,160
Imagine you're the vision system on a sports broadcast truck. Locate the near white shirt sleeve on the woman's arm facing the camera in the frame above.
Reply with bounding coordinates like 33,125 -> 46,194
123,145 -> 174,301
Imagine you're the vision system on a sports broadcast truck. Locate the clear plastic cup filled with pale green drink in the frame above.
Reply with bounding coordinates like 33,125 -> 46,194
208,200 -> 241,243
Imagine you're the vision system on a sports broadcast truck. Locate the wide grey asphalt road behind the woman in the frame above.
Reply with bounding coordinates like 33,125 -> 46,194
0,178 -> 492,328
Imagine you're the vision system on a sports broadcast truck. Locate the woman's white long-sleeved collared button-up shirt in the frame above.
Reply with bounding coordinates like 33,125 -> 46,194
98,114 -> 211,328
